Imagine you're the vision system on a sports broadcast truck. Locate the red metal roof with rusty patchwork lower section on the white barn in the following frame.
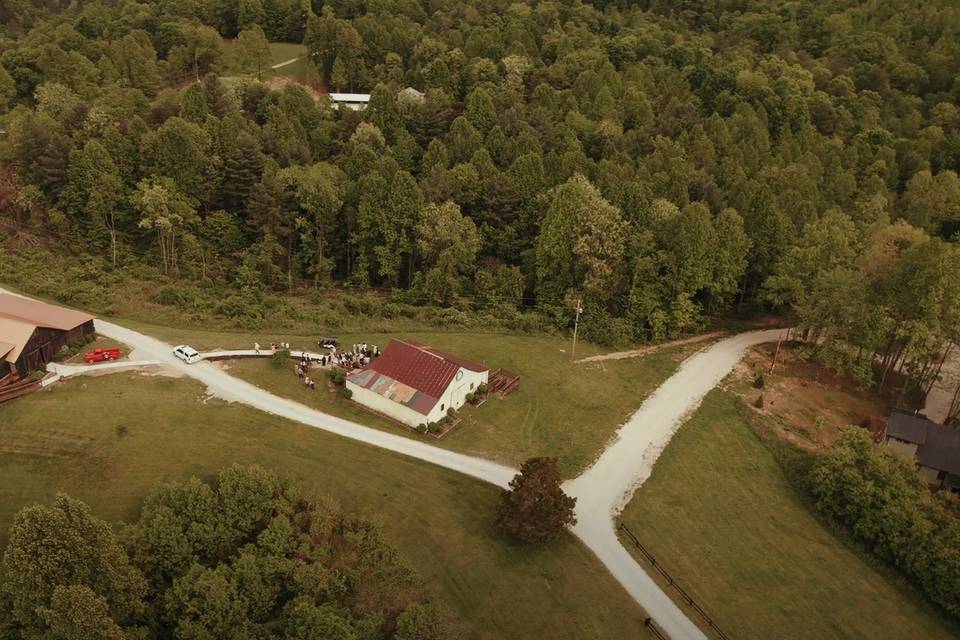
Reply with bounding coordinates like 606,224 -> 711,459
348,340 -> 487,415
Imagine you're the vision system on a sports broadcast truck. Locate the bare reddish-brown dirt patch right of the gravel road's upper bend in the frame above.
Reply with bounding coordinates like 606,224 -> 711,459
732,344 -> 890,449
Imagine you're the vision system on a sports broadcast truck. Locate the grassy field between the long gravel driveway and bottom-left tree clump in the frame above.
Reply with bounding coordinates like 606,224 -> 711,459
0,373 -> 647,640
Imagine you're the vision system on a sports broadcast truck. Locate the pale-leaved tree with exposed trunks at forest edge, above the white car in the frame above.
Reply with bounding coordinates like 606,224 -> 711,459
133,177 -> 197,275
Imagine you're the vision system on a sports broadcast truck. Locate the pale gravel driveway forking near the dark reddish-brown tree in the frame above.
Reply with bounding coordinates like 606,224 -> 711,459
1,286 -> 785,640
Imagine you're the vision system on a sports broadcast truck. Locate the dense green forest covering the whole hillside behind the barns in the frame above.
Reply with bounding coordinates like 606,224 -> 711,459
0,0 -> 960,396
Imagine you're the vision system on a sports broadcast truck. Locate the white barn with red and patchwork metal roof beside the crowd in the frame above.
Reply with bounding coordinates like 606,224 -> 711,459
347,340 -> 490,427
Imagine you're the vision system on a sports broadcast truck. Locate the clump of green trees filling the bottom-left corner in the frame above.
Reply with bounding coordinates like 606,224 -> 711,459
0,465 -> 454,640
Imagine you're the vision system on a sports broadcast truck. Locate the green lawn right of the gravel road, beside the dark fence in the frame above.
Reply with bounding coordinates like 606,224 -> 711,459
622,391 -> 958,640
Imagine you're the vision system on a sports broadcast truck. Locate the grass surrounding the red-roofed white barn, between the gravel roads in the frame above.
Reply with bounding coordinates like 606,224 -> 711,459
116,325 -> 704,477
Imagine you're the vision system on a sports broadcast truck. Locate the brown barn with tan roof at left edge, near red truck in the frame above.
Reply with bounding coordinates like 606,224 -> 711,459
0,293 -> 93,378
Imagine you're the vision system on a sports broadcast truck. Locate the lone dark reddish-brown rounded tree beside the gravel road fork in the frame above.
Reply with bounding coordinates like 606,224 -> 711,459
497,458 -> 577,544
